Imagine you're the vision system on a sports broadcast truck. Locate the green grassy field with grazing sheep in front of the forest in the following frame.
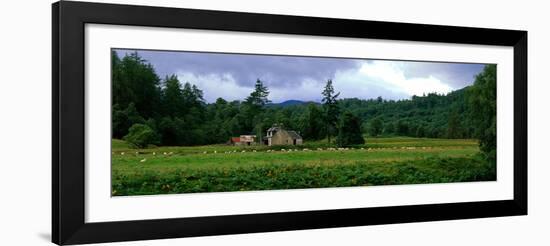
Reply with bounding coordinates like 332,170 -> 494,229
112,137 -> 496,196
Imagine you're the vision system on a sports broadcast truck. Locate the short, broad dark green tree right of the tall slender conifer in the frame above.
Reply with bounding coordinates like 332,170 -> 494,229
336,111 -> 365,146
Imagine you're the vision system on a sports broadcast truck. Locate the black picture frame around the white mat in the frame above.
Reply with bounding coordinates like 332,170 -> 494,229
52,1 -> 527,244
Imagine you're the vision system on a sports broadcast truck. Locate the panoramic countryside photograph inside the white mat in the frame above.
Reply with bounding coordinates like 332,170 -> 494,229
111,49 -> 497,196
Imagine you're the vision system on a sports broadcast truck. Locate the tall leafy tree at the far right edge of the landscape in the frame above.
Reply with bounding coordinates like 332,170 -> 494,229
467,64 -> 497,161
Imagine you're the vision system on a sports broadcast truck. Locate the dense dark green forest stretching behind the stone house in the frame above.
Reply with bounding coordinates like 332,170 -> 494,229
111,51 -> 496,160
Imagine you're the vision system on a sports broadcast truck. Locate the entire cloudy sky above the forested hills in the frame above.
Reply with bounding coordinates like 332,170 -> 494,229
116,50 -> 484,103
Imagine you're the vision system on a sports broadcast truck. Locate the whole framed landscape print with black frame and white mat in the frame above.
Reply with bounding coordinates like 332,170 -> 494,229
52,1 -> 527,244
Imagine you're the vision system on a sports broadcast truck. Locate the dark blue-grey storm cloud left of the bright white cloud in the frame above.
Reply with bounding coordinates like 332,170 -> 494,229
117,50 -> 359,87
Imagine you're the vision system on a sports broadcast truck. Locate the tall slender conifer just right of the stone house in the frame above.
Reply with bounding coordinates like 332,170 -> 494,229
321,79 -> 340,143
